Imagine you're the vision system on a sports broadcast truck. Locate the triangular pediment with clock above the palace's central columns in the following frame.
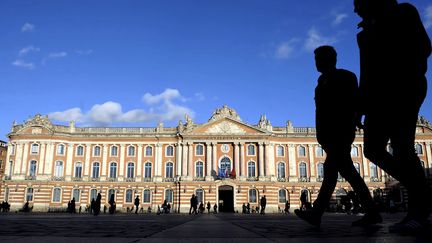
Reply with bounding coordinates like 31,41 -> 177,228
191,118 -> 266,135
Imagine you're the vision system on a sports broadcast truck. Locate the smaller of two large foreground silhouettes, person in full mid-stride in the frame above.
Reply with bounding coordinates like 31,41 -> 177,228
294,46 -> 382,226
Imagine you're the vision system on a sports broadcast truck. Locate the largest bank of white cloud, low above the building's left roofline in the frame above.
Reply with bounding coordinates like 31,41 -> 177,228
48,89 -> 195,126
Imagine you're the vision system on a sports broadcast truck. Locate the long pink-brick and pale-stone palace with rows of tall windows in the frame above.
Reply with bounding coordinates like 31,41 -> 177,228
0,106 -> 432,212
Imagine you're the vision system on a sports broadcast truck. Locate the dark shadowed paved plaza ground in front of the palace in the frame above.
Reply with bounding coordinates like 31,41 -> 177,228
0,213 -> 432,243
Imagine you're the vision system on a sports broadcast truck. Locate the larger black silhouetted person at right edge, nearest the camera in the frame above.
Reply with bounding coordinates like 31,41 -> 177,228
354,0 -> 432,232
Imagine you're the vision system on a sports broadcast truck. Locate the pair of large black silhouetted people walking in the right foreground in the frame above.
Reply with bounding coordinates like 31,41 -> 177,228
295,0 -> 432,233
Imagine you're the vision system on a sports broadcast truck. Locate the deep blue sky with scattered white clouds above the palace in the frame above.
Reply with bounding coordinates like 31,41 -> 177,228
0,0 -> 432,141
